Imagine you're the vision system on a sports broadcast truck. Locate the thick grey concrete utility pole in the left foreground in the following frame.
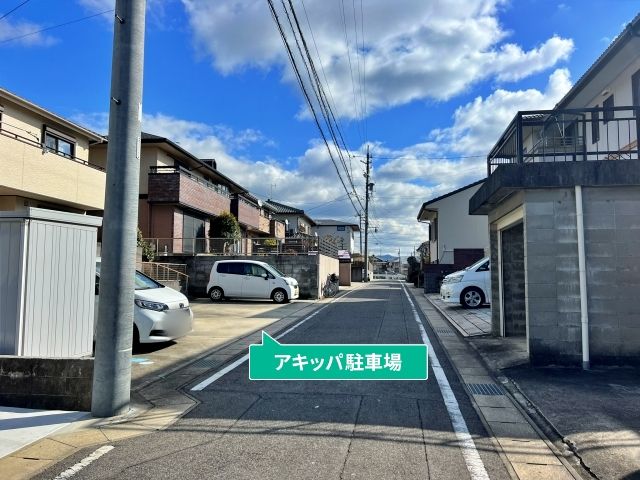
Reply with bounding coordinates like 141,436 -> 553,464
91,0 -> 146,417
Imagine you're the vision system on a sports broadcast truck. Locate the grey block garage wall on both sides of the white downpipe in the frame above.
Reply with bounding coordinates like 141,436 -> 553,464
525,187 -> 640,365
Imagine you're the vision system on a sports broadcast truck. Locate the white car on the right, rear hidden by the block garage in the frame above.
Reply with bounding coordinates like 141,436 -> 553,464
440,257 -> 491,308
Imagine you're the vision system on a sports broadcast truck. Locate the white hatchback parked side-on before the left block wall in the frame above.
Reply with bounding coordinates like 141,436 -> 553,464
207,260 -> 300,303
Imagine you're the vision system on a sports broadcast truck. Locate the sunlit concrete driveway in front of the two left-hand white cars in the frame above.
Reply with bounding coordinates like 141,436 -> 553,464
131,299 -> 317,390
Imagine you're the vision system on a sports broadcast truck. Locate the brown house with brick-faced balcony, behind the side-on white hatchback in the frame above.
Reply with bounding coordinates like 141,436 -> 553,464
91,133 -> 281,254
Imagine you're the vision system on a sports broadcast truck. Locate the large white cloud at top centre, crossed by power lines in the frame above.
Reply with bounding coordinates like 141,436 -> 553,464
182,0 -> 573,118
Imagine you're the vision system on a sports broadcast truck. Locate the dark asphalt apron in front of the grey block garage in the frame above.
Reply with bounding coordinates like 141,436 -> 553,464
420,286 -> 640,480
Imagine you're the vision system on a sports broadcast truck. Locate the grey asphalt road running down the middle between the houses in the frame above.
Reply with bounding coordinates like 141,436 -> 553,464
38,282 -> 509,480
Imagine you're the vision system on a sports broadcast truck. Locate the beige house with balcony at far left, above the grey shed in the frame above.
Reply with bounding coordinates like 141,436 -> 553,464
0,88 -> 105,213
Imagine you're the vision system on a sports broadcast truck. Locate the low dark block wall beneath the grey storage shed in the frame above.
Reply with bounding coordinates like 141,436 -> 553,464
0,356 -> 93,411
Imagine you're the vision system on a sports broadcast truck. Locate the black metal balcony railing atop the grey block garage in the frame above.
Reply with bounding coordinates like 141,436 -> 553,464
487,106 -> 640,175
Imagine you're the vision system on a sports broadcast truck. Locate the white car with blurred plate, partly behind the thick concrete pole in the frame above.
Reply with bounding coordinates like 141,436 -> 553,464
95,262 -> 193,344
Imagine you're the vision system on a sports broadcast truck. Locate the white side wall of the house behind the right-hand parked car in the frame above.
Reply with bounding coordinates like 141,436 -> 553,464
429,184 -> 489,262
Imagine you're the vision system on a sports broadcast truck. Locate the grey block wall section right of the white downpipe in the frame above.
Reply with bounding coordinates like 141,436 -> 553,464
583,186 -> 640,364
